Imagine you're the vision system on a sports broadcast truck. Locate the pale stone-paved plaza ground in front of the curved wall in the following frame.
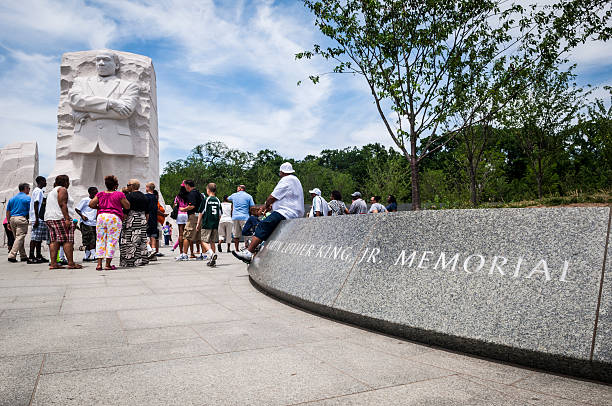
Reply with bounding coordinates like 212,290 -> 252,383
0,249 -> 612,406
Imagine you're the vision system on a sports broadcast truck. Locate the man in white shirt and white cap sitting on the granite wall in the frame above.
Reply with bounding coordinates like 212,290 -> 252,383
232,162 -> 304,264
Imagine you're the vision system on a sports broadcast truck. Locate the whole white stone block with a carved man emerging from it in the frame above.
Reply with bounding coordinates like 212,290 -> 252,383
51,50 -> 159,201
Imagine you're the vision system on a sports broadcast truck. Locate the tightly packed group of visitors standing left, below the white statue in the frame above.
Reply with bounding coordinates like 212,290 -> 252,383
4,175 -> 166,270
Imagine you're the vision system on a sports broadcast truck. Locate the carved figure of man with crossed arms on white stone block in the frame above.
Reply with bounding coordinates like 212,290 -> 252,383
68,52 -> 139,187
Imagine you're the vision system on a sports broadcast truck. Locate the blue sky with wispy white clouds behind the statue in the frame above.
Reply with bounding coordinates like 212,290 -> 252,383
0,0 -> 612,175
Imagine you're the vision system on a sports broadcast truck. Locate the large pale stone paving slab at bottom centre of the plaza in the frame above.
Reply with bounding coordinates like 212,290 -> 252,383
33,348 -> 367,405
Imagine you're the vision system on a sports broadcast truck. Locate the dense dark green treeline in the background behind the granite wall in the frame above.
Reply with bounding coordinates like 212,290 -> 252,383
161,101 -> 612,207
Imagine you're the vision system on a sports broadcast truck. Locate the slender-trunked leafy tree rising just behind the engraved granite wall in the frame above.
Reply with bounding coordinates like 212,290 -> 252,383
296,0 -> 612,209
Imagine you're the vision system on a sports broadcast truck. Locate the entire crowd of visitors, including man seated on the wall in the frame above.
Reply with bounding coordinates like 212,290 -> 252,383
4,162 -> 397,270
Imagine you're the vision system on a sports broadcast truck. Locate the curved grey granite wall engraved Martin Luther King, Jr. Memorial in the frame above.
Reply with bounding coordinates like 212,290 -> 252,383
249,207 -> 612,382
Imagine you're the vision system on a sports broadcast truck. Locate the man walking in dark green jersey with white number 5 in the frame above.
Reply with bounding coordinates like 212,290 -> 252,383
196,183 -> 222,267
